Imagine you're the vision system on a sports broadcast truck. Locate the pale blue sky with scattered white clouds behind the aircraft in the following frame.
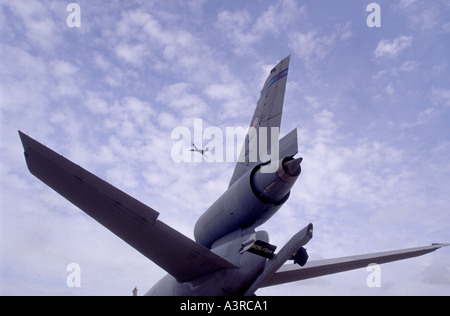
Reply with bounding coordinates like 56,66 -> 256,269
0,0 -> 450,295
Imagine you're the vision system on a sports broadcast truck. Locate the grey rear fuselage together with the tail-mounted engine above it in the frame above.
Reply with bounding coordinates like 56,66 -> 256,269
147,158 -> 301,296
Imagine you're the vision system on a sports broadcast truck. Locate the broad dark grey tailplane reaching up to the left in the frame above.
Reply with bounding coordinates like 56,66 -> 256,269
19,131 -> 237,282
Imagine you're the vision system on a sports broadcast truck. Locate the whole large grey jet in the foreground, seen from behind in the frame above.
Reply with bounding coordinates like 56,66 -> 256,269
19,56 -> 450,296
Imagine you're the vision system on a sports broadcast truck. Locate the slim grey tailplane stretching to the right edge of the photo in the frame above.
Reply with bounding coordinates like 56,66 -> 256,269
260,244 -> 450,287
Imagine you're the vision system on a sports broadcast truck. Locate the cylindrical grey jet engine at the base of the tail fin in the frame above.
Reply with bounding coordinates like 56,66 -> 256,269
194,157 -> 302,248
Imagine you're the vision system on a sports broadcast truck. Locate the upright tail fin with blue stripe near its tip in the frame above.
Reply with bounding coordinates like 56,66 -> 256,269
230,56 -> 297,186
